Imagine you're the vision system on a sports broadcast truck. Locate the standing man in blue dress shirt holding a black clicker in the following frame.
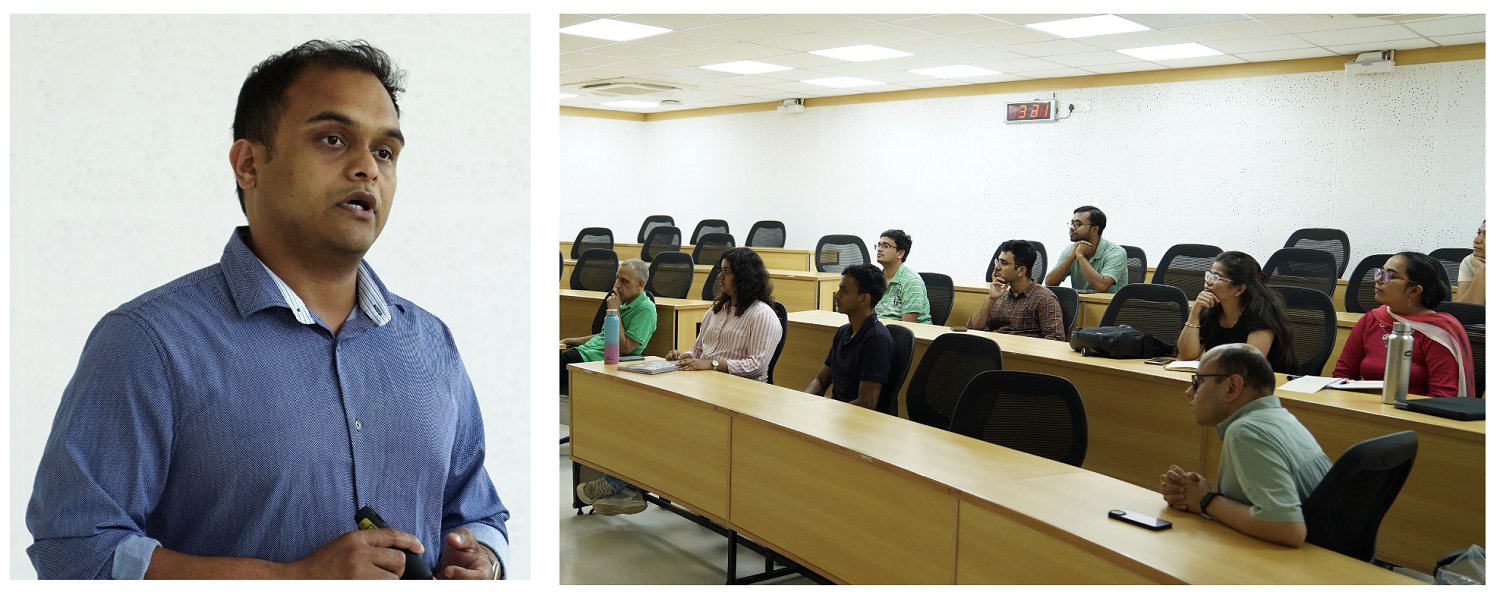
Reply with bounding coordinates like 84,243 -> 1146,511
26,42 -> 510,579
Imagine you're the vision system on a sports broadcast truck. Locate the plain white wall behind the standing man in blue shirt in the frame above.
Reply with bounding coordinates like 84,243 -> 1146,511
9,15 -> 534,579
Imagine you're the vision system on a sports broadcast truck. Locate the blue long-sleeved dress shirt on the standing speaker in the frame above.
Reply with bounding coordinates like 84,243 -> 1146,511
26,226 -> 510,579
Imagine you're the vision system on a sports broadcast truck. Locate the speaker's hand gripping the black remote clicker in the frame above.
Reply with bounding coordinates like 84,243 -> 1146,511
287,528 -> 425,580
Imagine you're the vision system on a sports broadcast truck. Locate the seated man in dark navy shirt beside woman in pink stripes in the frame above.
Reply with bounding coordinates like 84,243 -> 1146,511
807,264 -> 896,409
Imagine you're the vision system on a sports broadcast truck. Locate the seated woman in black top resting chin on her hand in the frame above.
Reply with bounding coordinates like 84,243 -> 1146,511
1178,250 -> 1301,375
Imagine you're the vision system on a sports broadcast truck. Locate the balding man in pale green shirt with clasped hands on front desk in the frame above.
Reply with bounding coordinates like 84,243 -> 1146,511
1161,343 -> 1334,547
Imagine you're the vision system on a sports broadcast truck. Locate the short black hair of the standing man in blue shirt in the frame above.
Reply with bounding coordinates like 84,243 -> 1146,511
234,39 -> 407,213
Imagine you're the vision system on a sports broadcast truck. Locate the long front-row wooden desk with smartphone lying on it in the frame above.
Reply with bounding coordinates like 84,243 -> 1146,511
569,363 -> 1412,585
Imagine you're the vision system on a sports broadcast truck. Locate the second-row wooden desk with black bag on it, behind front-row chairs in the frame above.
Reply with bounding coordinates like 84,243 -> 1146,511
776,310 -> 1485,573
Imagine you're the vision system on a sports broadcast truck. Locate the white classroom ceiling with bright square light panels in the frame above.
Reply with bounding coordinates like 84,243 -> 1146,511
560,13 -> 1485,112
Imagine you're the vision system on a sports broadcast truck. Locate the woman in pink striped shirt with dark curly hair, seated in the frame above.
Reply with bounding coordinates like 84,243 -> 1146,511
666,247 -> 782,382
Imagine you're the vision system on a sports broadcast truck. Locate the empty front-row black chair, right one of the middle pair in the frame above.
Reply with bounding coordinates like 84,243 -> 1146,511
948,370 -> 1089,466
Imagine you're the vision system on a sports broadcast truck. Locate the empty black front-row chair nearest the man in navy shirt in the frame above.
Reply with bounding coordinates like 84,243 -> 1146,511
906,333 -> 1001,430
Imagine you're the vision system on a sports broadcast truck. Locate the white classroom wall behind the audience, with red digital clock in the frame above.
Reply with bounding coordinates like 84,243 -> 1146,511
558,60 -> 1485,285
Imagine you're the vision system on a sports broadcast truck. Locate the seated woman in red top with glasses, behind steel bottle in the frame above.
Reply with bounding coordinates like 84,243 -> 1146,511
1334,252 -> 1475,397
